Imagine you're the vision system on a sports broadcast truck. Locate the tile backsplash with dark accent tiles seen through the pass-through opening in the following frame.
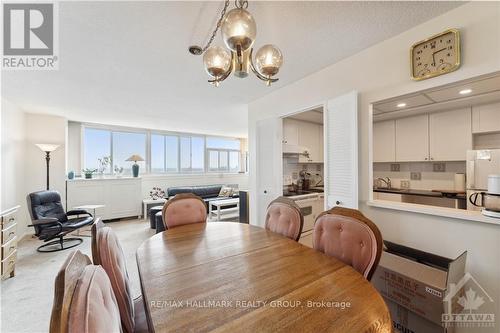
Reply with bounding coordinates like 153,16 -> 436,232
373,161 -> 466,190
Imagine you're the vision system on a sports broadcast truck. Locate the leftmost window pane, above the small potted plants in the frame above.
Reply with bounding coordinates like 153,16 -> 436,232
83,128 -> 111,173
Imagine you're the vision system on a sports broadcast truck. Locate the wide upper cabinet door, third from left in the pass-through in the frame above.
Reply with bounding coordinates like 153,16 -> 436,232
429,108 -> 472,161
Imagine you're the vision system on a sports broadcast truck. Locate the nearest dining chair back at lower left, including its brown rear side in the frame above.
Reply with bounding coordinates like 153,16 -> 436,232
50,251 -> 121,333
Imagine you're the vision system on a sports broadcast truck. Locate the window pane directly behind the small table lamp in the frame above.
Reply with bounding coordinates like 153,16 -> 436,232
112,132 -> 146,173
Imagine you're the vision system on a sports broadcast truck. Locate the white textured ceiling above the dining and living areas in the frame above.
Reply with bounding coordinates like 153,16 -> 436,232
2,2 -> 461,136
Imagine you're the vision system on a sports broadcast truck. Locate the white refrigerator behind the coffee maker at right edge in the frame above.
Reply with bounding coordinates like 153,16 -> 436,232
466,149 -> 500,210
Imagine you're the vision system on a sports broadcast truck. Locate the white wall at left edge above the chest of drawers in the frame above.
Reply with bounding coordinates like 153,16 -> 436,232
0,99 -> 29,235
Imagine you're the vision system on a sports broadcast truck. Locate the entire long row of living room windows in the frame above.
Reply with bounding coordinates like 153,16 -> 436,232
83,127 -> 240,174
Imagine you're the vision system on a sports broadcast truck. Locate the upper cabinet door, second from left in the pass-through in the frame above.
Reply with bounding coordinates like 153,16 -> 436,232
395,114 -> 429,162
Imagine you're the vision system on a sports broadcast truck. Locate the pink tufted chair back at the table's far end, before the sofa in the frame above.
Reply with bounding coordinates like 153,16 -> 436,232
162,193 -> 207,229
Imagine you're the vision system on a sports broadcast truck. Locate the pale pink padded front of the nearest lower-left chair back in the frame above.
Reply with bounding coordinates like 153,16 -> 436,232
67,265 -> 122,333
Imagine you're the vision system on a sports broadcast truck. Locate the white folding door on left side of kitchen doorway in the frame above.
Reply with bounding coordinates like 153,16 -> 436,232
254,118 -> 283,226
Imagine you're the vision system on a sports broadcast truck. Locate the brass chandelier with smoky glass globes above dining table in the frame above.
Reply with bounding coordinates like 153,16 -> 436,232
189,0 -> 283,87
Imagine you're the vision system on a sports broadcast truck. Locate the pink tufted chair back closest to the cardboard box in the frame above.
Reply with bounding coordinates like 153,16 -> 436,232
313,207 -> 382,280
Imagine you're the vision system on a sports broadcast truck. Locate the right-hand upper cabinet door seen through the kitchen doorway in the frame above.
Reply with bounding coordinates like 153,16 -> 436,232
299,121 -> 323,163
